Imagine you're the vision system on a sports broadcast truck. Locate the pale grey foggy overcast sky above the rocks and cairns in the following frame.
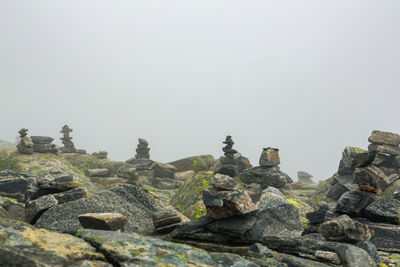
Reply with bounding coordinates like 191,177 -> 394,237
0,0 -> 400,179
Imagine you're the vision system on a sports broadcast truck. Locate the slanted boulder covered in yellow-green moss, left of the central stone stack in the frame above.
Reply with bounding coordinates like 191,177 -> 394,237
170,172 -> 214,219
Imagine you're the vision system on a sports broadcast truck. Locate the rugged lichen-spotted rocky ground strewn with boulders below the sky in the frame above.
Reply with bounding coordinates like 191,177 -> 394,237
0,132 -> 400,267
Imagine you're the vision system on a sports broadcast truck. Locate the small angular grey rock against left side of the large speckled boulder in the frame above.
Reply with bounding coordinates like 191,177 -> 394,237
25,195 -> 58,224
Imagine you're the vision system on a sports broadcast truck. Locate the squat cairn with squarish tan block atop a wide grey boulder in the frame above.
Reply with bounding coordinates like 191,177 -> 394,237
239,148 -> 293,189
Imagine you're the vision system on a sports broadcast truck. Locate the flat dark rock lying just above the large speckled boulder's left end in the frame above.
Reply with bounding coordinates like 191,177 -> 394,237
37,174 -> 79,193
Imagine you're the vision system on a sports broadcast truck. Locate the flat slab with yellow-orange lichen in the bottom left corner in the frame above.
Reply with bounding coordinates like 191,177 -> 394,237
0,218 -> 104,267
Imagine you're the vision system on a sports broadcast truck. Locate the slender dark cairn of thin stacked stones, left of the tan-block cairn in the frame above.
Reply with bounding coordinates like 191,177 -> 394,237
214,135 -> 239,177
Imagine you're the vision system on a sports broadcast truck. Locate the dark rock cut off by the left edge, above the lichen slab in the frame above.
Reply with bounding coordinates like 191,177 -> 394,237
0,175 -> 39,203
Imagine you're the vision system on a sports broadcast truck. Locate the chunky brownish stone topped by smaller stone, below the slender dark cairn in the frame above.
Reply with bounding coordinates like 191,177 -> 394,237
203,174 -> 257,219
